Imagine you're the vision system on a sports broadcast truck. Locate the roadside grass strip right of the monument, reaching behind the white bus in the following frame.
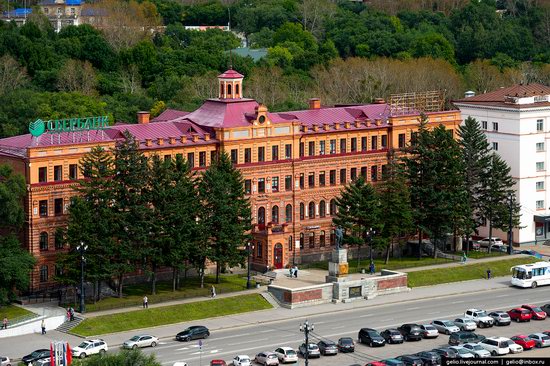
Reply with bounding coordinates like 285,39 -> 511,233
408,258 -> 540,287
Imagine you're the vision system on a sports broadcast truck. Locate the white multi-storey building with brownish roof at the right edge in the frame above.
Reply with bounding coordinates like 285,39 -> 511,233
454,84 -> 550,244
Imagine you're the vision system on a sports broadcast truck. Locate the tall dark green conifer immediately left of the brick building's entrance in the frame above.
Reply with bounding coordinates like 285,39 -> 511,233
199,153 -> 252,283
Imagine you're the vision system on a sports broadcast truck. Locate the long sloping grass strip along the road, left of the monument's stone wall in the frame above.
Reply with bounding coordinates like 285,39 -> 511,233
71,294 -> 272,337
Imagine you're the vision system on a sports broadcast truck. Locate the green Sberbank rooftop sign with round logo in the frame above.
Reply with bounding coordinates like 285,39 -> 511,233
29,116 -> 109,137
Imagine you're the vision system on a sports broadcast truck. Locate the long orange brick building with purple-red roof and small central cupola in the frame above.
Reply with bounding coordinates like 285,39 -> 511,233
0,70 -> 461,291
